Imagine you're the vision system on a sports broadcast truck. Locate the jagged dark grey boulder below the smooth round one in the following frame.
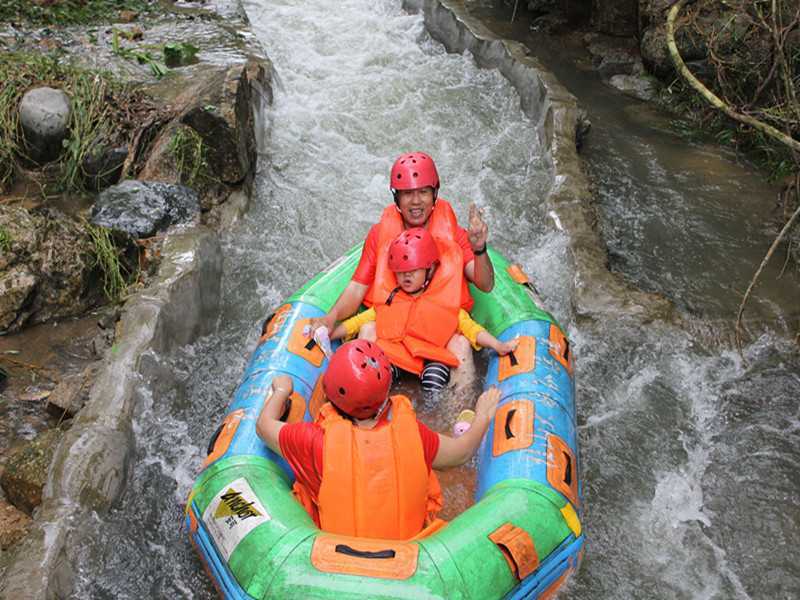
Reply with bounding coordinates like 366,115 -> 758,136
91,179 -> 200,238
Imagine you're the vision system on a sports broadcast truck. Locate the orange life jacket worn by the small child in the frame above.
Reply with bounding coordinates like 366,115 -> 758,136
374,239 -> 464,375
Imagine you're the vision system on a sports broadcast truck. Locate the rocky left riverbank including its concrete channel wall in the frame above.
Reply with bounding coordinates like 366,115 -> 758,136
0,1 -> 271,598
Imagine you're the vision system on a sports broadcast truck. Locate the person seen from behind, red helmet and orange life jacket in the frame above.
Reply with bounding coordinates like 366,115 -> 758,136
256,340 -> 500,540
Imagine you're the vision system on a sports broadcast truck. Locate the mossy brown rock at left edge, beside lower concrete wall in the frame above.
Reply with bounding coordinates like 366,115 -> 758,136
0,429 -> 62,515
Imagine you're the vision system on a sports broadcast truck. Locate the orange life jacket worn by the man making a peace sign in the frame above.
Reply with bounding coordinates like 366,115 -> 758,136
364,198 -> 474,312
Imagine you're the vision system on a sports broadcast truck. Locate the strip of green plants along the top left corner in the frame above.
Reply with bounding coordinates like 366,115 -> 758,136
0,0 -> 154,26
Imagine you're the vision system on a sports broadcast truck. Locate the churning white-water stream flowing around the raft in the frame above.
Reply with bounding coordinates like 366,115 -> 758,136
74,0 -> 800,599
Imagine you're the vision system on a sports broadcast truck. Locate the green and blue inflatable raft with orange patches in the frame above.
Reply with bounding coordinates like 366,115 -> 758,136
186,246 -> 584,600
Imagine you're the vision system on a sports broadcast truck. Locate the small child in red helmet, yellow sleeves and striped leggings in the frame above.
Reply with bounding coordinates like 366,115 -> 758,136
330,227 -> 518,392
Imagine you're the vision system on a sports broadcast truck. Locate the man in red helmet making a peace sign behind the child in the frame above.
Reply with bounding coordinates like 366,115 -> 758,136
311,152 -> 494,382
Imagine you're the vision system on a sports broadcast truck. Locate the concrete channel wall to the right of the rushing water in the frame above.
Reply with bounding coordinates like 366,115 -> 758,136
403,0 -> 673,321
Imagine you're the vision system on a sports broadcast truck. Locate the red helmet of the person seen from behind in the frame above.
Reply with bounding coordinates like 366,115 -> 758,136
322,340 -> 392,419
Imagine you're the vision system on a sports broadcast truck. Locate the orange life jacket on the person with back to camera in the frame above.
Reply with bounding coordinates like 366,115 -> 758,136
295,396 -> 442,540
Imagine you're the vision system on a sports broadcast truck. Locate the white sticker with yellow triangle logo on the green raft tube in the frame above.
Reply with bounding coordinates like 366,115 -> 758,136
203,477 -> 272,561
